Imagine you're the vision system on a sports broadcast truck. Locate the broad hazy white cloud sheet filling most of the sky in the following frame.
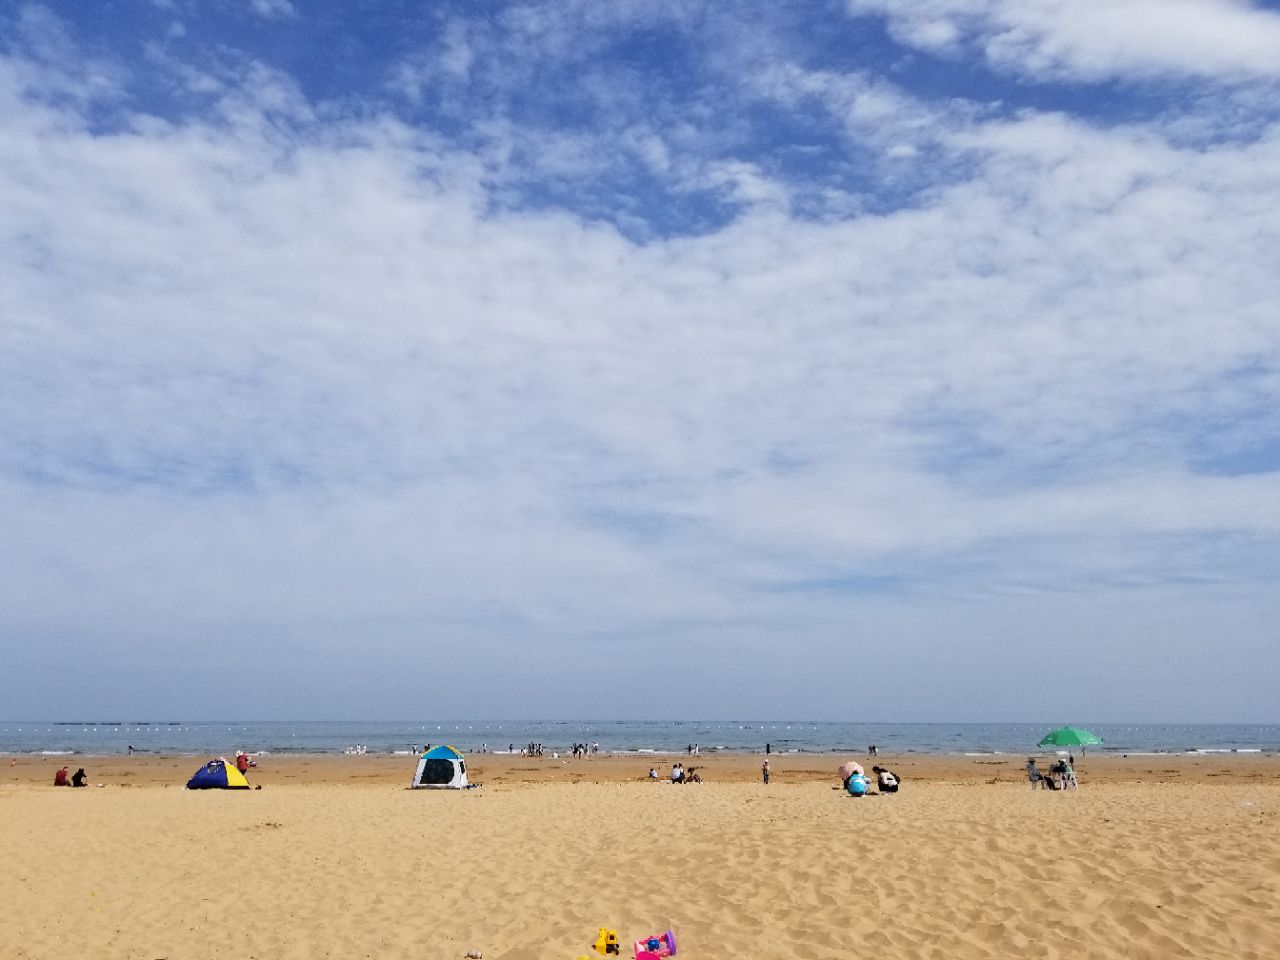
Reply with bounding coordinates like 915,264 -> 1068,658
0,18 -> 1280,704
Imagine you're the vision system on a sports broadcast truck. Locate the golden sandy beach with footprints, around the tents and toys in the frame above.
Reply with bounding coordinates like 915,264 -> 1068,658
0,756 -> 1280,960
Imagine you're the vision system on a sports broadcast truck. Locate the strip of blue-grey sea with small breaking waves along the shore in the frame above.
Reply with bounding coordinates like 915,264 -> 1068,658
0,717 -> 1280,756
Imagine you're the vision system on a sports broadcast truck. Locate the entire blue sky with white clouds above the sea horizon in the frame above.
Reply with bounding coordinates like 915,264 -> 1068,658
0,0 -> 1280,722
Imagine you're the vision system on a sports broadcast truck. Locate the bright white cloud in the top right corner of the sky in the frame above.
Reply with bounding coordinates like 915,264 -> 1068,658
849,0 -> 1280,81
